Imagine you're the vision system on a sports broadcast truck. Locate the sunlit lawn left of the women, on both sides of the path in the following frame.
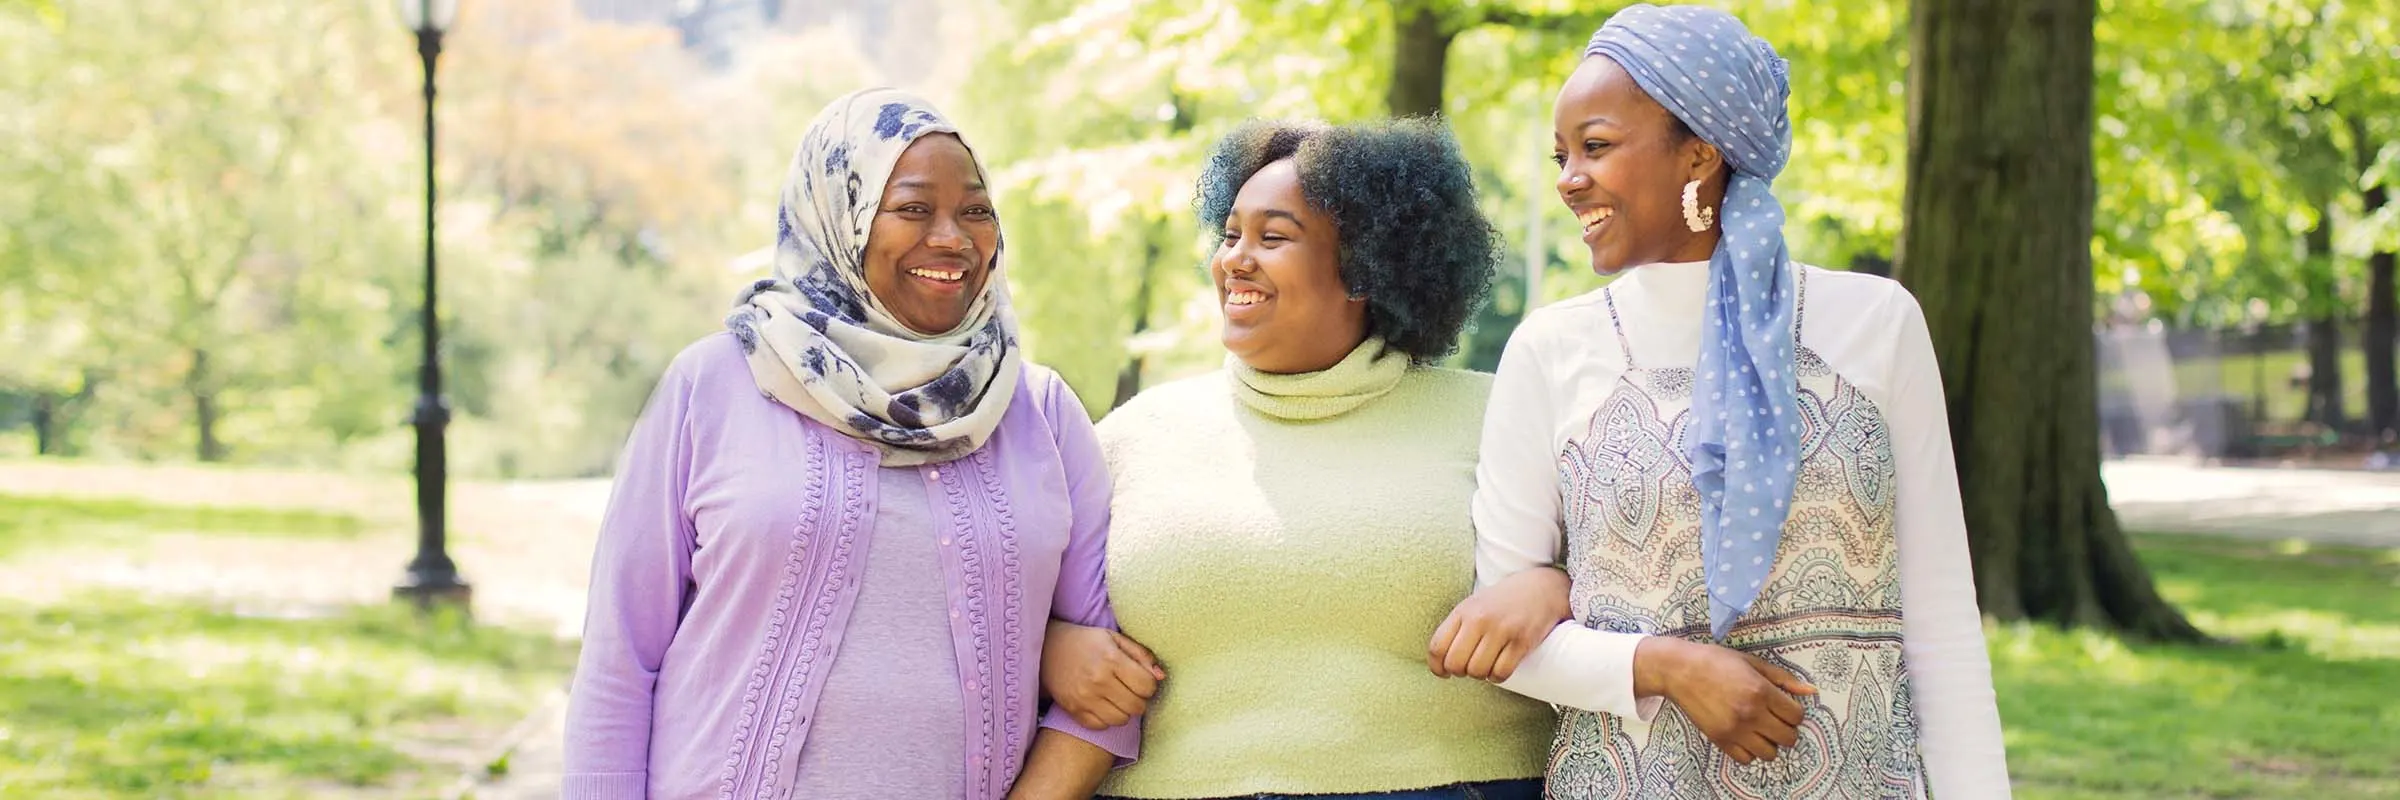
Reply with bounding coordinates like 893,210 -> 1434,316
0,495 -> 574,800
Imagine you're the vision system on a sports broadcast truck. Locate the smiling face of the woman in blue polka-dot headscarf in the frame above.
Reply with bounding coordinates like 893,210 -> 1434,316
1550,55 -> 1726,274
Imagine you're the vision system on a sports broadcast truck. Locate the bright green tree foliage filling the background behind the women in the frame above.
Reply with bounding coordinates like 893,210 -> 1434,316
0,0 -> 2400,461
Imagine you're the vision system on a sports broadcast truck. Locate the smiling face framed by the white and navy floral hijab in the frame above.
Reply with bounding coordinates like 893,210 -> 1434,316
866,135 -> 1001,336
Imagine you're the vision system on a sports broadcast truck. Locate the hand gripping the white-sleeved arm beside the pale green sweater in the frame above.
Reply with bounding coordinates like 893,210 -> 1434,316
1426,567 -> 1570,682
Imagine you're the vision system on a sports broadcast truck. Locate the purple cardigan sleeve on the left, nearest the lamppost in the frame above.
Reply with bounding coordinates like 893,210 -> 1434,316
564,370 -> 694,800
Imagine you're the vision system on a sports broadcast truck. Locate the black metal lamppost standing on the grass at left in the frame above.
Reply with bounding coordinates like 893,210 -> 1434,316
391,0 -> 473,605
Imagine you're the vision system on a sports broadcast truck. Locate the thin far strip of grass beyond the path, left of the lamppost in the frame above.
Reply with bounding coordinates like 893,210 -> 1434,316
0,495 -> 367,557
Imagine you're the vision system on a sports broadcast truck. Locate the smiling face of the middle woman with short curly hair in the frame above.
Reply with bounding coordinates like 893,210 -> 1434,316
1210,159 -> 1366,372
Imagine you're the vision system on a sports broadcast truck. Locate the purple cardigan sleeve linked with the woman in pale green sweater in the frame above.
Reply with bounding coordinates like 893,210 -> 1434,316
1042,377 -> 1142,766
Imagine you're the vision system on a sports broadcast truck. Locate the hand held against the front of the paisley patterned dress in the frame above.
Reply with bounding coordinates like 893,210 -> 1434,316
1634,637 -> 1817,764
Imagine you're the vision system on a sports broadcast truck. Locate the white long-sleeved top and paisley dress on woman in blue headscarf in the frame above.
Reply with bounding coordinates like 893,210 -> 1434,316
1474,262 -> 2009,800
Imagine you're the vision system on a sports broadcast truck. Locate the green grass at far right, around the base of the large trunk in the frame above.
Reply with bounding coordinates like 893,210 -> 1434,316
1992,536 -> 2400,798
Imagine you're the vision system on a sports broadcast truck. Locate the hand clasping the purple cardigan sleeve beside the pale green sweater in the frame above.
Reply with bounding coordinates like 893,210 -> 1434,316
1042,620 -> 1166,730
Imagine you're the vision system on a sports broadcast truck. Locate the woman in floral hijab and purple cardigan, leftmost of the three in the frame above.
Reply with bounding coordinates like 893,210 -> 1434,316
566,89 -> 1140,800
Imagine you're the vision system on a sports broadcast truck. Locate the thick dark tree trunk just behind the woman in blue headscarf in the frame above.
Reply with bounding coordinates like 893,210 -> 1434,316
1896,0 -> 2201,639
